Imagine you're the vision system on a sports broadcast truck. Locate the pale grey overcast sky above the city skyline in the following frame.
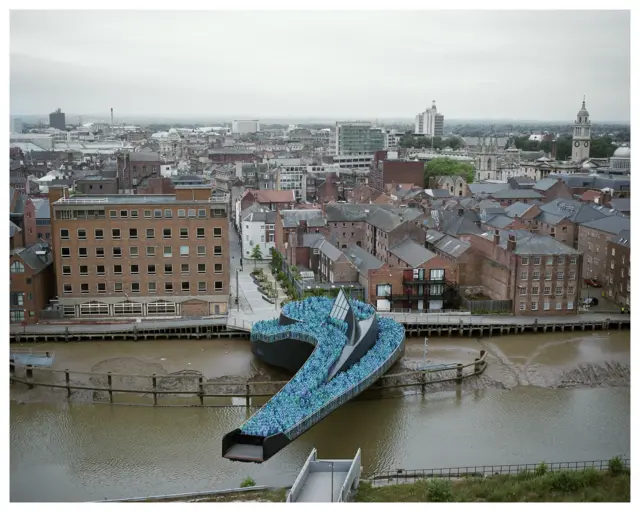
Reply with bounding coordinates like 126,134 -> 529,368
10,11 -> 630,121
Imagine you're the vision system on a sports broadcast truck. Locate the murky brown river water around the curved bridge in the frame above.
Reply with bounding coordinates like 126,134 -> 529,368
10,331 -> 630,501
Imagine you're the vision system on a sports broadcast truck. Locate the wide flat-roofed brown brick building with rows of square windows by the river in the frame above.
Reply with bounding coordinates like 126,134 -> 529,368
49,185 -> 229,318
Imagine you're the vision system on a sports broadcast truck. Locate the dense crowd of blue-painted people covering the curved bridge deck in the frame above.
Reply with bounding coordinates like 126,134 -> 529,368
241,297 -> 404,437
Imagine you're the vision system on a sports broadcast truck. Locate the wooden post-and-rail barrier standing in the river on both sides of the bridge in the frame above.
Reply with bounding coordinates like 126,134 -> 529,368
9,350 -> 487,407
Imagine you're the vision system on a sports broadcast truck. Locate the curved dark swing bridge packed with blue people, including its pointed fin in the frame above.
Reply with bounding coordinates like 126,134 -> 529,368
222,290 -> 404,462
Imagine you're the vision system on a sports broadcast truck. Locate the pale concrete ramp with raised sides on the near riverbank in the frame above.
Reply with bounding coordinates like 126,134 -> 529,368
287,448 -> 362,503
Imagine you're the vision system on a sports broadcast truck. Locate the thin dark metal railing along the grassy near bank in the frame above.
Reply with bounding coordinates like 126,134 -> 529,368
363,459 -> 631,485
